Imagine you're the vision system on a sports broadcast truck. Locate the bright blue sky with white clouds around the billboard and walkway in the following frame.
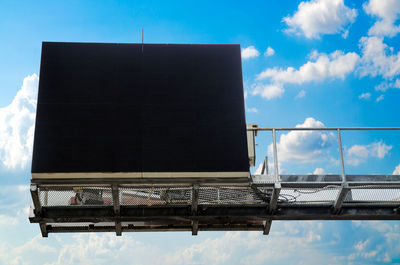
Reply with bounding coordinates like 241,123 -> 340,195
0,0 -> 400,264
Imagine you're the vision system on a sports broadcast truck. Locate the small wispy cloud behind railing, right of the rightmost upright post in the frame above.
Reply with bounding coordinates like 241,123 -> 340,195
346,140 -> 392,166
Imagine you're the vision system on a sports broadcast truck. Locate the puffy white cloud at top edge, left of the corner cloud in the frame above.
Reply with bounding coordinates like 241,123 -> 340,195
283,0 -> 357,39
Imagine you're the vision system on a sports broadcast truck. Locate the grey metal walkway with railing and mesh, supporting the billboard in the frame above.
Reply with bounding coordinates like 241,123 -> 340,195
29,128 -> 400,237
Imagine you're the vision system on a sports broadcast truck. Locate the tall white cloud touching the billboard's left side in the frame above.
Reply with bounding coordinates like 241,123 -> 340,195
0,74 -> 39,169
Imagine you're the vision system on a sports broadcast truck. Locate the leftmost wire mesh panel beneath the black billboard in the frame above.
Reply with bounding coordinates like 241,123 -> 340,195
39,186 -> 113,207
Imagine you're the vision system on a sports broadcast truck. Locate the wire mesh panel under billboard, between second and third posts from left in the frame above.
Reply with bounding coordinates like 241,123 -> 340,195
119,186 -> 192,206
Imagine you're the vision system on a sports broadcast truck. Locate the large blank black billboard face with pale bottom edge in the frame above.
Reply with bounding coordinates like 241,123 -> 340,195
32,42 -> 249,178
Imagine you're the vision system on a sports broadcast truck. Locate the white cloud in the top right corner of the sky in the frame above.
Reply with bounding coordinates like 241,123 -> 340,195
363,0 -> 400,37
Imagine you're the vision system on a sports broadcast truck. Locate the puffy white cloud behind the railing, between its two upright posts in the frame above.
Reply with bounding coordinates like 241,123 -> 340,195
268,118 -> 336,163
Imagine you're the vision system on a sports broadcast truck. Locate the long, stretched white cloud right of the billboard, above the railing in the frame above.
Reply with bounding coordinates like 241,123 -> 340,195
252,50 -> 360,99
